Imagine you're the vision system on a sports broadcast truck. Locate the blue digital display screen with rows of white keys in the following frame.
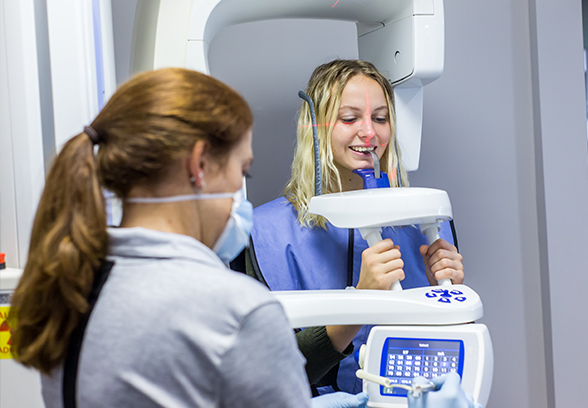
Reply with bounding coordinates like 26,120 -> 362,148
380,337 -> 464,397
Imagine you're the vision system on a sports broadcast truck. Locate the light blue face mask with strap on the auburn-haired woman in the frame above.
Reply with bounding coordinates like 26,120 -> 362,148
126,190 -> 253,265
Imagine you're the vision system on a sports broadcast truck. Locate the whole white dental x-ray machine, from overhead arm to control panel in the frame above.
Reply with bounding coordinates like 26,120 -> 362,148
131,0 -> 493,407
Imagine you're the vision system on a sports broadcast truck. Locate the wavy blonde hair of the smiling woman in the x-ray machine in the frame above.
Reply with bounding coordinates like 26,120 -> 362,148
284,60 -> 408,228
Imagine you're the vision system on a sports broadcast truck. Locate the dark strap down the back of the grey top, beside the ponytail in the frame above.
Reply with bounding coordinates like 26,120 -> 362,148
63,261 -> 114,408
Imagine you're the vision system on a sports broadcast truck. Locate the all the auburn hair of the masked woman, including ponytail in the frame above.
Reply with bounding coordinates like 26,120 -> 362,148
9,68 -> 253,373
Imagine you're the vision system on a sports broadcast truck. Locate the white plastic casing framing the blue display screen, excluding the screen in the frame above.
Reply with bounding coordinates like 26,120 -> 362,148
363,323 -> 494,408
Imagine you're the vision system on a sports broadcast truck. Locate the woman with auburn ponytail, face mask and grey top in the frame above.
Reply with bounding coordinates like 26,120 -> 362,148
10,69 -> 367,408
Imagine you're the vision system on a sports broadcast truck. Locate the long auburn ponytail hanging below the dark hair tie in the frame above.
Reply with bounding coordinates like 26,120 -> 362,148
10,133 -> 107,373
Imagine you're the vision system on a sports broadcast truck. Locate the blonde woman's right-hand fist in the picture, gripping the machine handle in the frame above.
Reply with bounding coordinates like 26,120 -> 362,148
420,239 -> 464,285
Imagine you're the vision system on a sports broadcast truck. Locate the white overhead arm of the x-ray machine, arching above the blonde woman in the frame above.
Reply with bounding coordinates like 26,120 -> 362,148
131,0 -> 445,171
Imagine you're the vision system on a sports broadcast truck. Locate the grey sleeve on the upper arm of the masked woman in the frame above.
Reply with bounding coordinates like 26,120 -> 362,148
220,303 -> 311,408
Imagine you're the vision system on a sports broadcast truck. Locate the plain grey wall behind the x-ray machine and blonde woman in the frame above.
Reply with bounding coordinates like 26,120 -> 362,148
113,0 -> 588,408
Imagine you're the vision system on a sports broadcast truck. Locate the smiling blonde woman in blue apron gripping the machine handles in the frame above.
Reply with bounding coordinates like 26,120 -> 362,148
241,60 -> 464,393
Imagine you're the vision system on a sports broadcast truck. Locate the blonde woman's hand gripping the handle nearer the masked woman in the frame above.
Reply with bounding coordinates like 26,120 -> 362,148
357,238 -> 404,290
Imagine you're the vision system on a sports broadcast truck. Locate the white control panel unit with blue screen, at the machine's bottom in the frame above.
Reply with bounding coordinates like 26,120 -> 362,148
363,323 -> 494,408
